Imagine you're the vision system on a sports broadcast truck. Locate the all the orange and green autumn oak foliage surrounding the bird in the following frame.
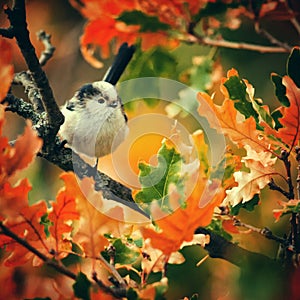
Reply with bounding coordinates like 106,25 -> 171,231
0,0 -> 300,299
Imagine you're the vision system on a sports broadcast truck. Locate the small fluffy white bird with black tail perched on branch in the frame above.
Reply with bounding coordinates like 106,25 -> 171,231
59,43 -> 135,163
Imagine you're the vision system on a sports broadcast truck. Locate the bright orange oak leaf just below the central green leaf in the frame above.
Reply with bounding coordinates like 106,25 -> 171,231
141,178 -> 225,255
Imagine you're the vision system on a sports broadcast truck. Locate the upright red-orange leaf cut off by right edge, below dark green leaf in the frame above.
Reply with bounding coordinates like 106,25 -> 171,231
278,76 -> 300,148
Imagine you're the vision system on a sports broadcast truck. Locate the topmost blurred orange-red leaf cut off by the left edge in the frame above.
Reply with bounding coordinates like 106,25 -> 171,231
0,37 -> 14,101
